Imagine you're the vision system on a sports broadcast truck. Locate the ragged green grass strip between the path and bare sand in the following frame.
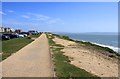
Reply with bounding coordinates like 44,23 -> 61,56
47,33 -> 100,79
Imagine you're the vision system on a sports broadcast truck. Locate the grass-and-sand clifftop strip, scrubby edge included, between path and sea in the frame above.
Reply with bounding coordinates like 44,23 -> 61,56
47,33 -> 120,78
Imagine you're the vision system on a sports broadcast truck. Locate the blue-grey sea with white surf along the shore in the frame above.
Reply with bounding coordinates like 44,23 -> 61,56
56,32 -> 120,53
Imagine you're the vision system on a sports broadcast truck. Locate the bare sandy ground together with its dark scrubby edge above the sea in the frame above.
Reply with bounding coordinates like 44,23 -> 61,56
50,34 -> 119,77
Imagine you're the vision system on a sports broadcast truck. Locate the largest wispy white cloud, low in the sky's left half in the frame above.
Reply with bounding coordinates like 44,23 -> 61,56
3,13 -> 62,27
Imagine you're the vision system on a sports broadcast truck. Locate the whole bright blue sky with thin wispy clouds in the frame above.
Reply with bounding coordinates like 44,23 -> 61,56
0,2 -> 118,33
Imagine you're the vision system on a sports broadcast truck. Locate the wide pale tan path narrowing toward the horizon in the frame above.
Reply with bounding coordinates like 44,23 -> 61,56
0,34 -> 53,77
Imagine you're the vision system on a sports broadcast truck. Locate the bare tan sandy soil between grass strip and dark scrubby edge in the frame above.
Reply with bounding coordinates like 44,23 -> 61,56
53,37 -> 118,77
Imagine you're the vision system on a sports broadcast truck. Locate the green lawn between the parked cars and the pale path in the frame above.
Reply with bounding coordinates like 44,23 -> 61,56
1,34 -> 40,61
